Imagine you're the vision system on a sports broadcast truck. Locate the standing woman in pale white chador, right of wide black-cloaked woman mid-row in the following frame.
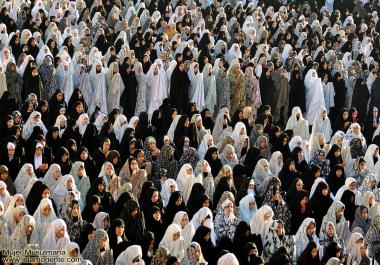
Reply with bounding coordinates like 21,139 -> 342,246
188,63 -> 205,109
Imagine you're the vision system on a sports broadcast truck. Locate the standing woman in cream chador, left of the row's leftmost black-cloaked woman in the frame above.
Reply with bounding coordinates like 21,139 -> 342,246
106,62 -> 125,111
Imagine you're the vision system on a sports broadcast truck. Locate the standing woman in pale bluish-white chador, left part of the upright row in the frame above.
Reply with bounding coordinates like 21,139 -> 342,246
88,61 -> 108,113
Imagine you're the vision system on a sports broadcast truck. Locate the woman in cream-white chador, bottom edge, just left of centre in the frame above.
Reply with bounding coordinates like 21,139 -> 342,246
160,224 -> 185,261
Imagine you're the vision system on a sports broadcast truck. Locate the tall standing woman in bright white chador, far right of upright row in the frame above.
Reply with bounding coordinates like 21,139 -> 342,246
304,69 -> 325,125
